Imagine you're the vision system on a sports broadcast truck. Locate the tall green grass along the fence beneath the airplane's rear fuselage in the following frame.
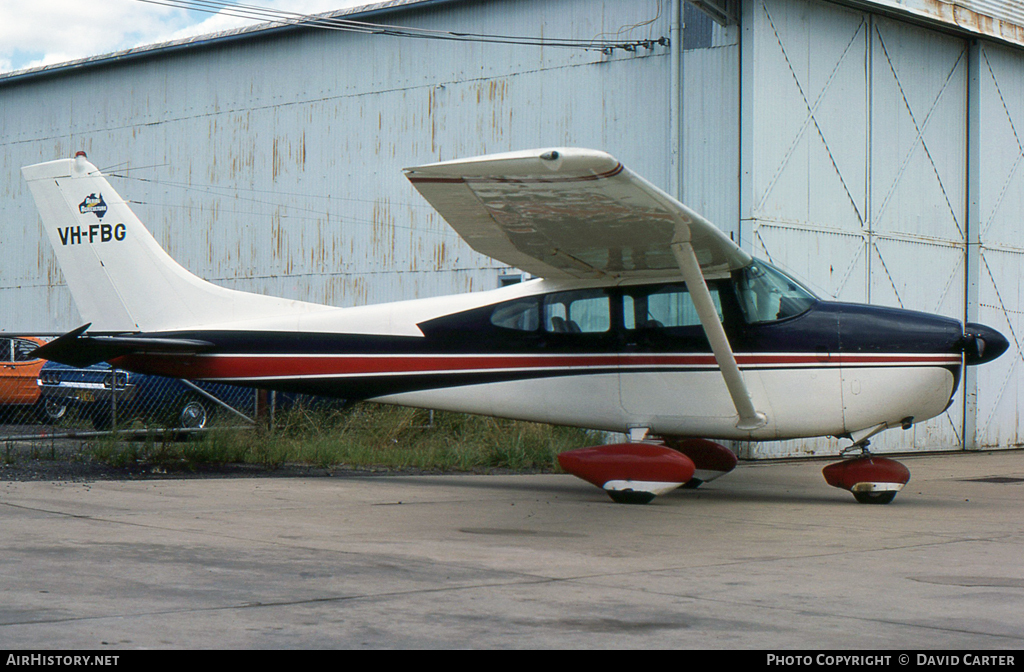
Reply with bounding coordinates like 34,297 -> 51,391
92,404 -> 602,471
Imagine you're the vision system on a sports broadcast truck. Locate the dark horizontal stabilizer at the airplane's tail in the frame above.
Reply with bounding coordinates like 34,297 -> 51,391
33,325 -> 214,367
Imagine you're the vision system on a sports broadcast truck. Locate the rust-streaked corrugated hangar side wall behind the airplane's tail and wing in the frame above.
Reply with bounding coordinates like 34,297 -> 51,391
0,0 -> 669,331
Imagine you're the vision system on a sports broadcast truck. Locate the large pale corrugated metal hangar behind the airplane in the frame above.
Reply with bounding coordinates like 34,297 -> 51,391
0,0 -> 1024,457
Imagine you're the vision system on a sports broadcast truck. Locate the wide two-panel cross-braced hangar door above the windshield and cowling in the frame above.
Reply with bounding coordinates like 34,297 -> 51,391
740,0 -> 968,457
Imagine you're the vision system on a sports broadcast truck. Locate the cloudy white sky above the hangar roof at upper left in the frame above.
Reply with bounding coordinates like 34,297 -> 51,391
0,0 -> 374,72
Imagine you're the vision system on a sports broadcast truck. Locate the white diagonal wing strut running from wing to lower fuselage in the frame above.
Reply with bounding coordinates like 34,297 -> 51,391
672,243 -> 768,430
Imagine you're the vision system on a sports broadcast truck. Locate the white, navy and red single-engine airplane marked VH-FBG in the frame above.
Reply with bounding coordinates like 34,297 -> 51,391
22,149 -> 1008,503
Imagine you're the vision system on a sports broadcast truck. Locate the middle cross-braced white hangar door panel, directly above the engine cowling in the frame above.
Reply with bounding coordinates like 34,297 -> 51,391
864,17 -> 968,451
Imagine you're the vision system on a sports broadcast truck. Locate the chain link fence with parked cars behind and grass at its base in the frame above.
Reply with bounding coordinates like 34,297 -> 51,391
0,336 -> 607,478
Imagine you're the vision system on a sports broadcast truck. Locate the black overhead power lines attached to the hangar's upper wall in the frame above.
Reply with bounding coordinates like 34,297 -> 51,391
138,0 -> 669,53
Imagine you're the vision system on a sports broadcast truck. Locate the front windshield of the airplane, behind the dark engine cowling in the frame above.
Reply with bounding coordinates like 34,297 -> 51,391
733,259 -> 818,324
